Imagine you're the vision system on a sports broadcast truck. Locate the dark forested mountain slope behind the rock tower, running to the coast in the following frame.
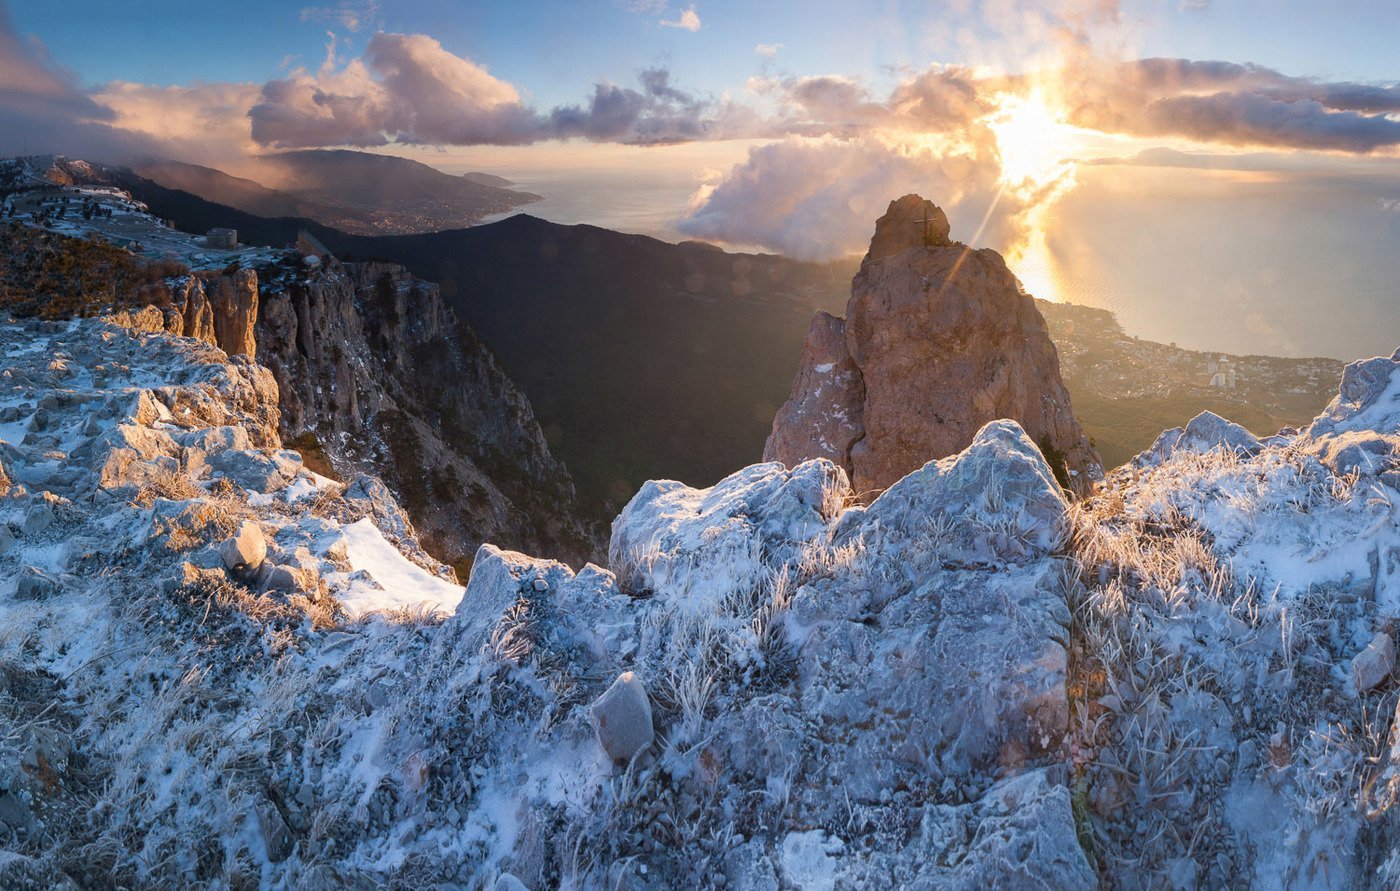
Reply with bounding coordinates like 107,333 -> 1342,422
63,165 -> 1340,504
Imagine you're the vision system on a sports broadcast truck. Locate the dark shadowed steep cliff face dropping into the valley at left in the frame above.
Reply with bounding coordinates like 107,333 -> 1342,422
256,258 -> 595,563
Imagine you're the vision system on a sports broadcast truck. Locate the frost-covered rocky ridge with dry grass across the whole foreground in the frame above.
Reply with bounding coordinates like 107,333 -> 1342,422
0,297 -> 1400,888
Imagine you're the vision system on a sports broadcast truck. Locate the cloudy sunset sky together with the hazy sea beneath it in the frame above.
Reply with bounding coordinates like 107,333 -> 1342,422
0,0 -> 1400,357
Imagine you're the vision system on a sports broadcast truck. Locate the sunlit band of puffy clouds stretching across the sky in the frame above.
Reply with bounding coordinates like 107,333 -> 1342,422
0,0 -> 1400,258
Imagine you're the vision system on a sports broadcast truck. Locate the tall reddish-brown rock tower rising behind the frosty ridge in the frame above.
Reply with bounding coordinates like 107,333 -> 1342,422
764,195 -> 1102,497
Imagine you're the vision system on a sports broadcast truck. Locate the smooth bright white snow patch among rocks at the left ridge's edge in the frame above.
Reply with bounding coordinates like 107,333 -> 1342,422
340,517 -> 466,616
